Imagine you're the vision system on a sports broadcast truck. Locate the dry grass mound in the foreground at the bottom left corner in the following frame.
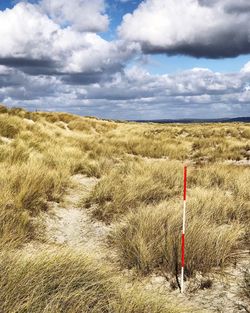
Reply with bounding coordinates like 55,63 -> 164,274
0,249 -> 184,313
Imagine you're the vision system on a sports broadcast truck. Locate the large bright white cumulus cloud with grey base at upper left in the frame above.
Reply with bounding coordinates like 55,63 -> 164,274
0,0 -> 137,76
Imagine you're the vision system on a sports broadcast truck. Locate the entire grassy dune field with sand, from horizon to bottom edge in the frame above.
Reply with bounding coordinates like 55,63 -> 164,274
0,106 -> 250,313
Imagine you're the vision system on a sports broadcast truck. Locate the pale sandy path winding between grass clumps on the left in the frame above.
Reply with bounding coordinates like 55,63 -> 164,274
45,175 -> 110,258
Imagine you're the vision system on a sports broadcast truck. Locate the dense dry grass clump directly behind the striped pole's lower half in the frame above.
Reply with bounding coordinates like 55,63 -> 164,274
111,202 -> 242,276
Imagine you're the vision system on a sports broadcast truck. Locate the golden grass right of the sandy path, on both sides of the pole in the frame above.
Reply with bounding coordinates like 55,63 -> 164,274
87,160 -> 250,275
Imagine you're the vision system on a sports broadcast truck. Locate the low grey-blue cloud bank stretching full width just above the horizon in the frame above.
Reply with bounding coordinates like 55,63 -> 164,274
0,62 -> 250,119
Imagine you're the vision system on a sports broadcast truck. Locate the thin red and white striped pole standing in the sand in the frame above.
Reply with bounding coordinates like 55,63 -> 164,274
181,166 -> 187,293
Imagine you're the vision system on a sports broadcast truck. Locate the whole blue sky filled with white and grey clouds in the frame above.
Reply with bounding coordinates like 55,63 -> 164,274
0,0 -> 250,120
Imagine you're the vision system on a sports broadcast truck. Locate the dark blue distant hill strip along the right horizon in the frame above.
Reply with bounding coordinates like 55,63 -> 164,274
134,116 -> 250,124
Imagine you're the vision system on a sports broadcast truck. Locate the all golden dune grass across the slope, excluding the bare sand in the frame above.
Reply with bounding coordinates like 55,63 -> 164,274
0,107 -> 250,312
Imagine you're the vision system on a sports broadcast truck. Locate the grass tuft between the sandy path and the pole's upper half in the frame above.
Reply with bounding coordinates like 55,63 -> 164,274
87,160 -> 182,221
